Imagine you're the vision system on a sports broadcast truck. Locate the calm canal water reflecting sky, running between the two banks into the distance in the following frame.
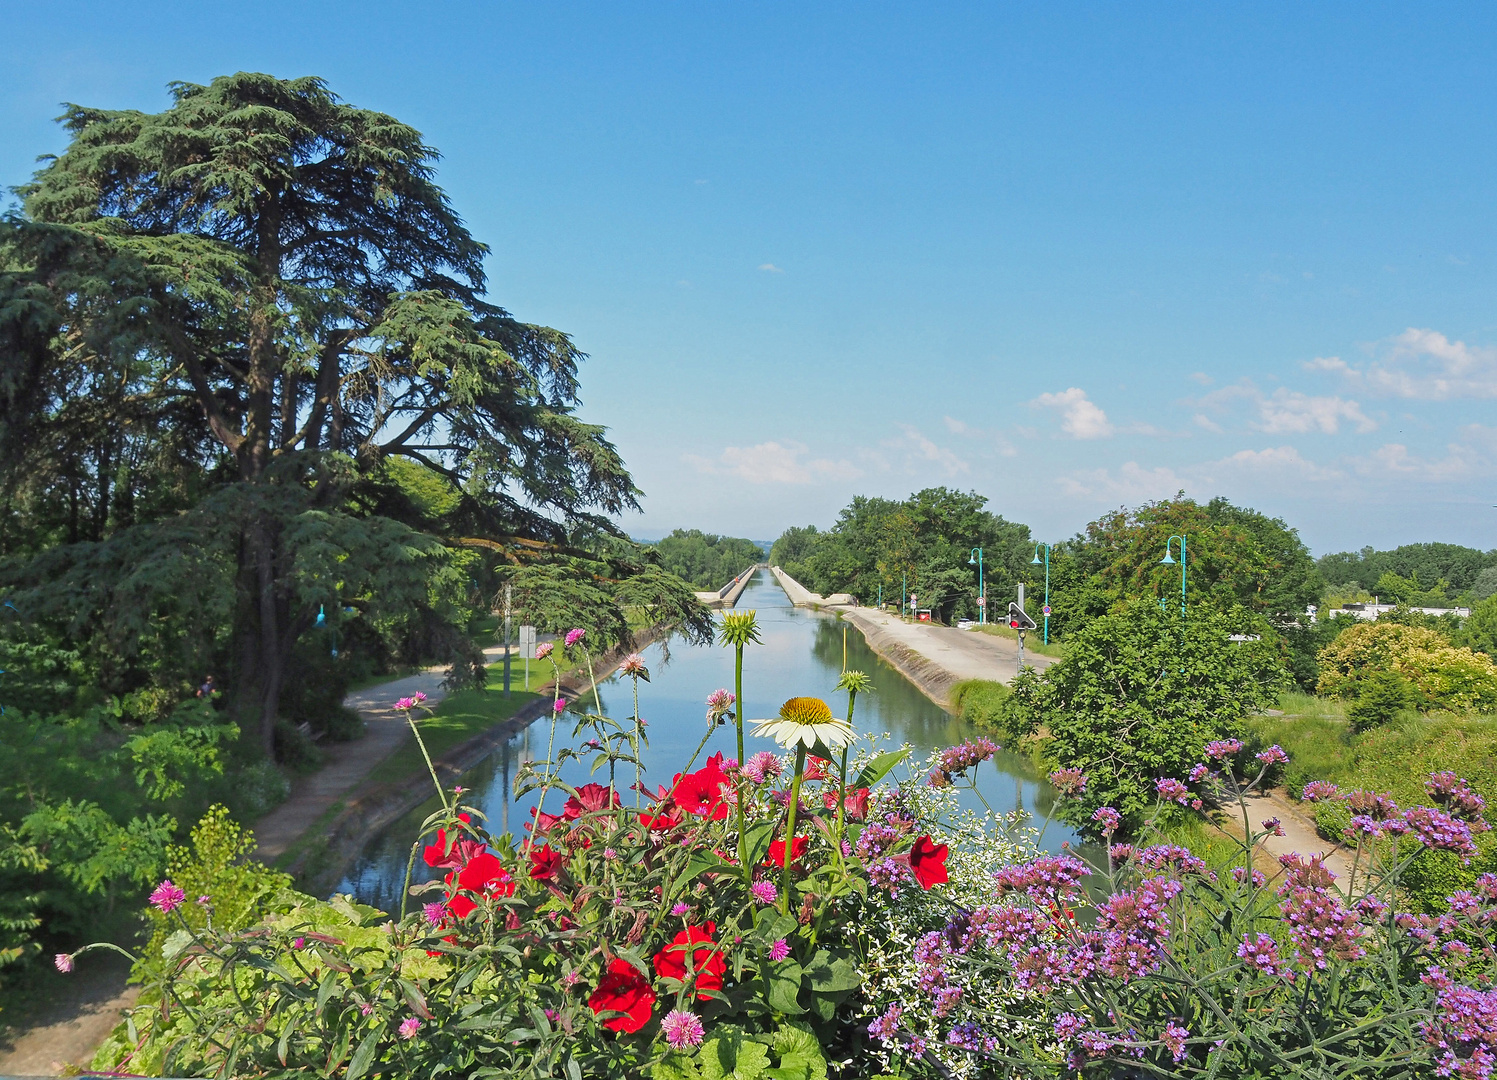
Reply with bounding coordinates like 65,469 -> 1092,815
334,571 -> 1078,911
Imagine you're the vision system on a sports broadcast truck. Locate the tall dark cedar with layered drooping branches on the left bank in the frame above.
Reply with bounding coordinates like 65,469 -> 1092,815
0,73 -> 636,749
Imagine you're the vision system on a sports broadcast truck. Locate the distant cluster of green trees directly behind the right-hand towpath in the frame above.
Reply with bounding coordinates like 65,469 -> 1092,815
769,487 -> 1043,622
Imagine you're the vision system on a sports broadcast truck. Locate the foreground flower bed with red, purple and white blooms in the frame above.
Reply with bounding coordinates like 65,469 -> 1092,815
72,620 -> 1497,1080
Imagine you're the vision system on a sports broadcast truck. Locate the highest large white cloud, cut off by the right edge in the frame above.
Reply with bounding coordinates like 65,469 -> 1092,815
1305,327 -> 1497,401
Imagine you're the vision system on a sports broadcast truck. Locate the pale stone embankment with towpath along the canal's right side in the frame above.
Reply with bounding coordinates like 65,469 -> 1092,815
769,566 -> 1055,709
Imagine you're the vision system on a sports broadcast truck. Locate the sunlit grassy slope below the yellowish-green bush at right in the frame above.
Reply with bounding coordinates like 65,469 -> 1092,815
1248,695 -> 1497,807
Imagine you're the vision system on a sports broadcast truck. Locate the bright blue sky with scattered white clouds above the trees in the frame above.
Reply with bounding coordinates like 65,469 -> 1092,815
0,3 -> 1497,553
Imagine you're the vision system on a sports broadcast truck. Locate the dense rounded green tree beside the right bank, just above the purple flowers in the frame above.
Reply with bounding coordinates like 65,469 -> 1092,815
1007,601 -> 1287,828
